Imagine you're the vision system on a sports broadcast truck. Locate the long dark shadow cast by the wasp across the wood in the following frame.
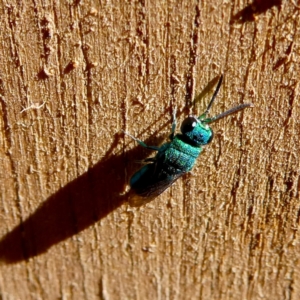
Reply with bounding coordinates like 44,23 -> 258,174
0,77 -> 217,264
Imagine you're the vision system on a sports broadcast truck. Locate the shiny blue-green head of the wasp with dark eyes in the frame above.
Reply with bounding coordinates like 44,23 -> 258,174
180,116 -> 214,146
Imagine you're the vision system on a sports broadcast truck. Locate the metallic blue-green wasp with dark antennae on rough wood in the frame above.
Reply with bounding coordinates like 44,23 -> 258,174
125,75 -> 253,206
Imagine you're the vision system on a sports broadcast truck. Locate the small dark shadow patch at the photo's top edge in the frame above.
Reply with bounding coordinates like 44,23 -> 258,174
230,0 -> 282,24
